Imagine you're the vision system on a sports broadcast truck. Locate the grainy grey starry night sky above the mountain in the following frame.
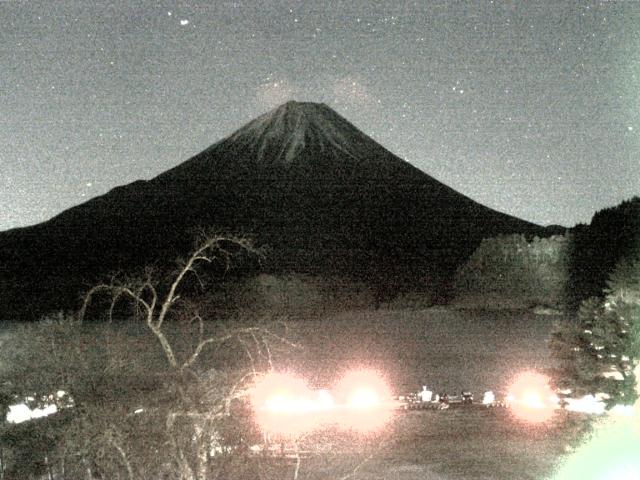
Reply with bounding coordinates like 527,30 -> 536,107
0,0 -> 640,230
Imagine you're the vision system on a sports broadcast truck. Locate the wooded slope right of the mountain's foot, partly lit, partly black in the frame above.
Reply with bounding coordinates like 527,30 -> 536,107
454,197 -> 640,308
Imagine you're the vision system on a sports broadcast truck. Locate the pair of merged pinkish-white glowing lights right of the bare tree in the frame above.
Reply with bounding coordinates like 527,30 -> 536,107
251,370 -> 392,437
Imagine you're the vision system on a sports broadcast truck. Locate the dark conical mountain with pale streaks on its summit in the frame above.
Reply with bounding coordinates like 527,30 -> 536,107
0,102 -> 547,319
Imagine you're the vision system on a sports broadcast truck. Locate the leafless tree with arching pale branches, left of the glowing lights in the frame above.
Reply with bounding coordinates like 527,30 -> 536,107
78,235 -> 304,480
